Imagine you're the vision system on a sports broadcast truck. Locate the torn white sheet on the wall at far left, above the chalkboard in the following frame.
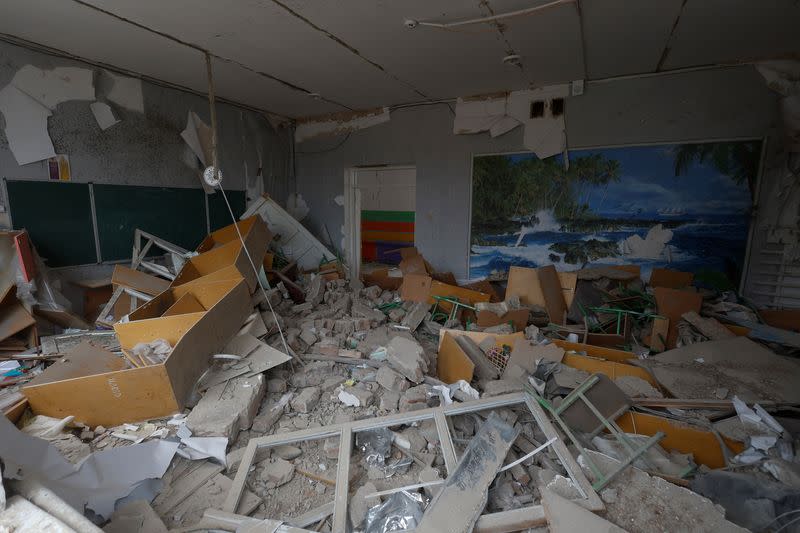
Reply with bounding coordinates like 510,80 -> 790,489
0,84 -> 56,165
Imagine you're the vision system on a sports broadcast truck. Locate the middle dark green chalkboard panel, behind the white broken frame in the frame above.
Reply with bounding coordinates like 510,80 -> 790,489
94,185 -> 206,261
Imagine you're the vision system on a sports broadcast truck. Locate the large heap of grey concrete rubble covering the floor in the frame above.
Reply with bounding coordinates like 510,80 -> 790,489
6,232 -> 800,532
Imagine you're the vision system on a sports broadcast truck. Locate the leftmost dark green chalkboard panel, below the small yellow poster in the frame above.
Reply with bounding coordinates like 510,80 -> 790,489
6,180 -> 97,267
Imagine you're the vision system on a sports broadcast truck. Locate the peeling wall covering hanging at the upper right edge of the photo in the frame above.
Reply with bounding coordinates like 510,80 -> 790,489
756,60 -> 800,152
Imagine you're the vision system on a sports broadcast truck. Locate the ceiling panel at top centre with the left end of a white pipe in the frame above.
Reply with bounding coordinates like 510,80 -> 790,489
280,0 -> 527,98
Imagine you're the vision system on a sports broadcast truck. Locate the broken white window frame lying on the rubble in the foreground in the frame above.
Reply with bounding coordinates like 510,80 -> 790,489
222,392 -> 605,533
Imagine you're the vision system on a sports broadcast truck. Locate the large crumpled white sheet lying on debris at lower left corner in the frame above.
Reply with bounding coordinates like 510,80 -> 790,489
0,417 -> 179,517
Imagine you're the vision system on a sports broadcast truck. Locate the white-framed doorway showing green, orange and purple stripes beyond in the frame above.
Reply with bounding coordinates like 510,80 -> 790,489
344,166 -> 417,279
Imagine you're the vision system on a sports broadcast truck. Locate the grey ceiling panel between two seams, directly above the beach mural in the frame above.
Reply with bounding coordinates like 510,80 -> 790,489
581,0 -> 683,79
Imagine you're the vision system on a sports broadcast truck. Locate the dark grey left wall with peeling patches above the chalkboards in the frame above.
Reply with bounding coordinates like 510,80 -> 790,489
0,38 -> 291,216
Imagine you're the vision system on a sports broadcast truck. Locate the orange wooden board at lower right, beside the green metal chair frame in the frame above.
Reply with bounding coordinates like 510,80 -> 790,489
617,411 -> 744,468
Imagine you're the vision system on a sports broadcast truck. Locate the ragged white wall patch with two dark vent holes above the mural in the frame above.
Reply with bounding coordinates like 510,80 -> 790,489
453,84 -> 569,159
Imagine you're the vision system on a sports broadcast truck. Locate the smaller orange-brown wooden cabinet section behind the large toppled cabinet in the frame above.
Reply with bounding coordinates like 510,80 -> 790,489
171,216 -> 272,294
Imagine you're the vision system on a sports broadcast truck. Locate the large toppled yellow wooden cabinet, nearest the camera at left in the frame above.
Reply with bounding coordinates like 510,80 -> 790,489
22,279 -> 251,427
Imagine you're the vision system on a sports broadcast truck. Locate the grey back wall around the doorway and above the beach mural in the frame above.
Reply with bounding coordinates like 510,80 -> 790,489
296,67 -> 777,278
